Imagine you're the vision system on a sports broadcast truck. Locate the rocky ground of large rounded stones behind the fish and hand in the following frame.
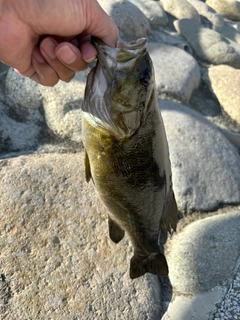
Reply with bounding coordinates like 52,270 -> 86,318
0,0 -> 240,320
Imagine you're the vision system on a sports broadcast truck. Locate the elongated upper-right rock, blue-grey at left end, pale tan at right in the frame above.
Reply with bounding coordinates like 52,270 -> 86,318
174,19 -> 240,69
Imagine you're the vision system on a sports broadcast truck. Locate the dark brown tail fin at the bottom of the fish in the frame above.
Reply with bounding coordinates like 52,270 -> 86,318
130,252 -> 168,279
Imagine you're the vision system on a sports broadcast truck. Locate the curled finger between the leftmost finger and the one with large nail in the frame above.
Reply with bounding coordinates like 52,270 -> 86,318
40,37 -> 75,82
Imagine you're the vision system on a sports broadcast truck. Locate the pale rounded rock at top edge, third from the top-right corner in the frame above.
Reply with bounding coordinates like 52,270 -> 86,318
160,0 -> 200,23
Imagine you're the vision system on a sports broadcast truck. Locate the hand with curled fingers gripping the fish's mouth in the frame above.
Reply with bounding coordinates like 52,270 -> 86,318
0,0 -> 118,86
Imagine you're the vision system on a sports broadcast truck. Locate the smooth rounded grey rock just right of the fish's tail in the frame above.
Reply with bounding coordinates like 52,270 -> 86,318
166,210 -> 240,293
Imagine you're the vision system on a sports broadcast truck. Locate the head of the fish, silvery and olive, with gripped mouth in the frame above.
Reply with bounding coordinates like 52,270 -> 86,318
84,38 -> 155,138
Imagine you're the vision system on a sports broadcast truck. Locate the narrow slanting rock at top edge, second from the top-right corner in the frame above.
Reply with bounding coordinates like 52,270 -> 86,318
187,0 -> 224,25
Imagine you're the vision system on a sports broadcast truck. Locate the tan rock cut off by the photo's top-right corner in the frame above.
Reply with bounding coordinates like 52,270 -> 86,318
206,0 -> 240,21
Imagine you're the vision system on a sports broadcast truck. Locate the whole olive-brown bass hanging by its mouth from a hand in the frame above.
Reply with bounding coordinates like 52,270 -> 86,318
82,38 -> 178,279
